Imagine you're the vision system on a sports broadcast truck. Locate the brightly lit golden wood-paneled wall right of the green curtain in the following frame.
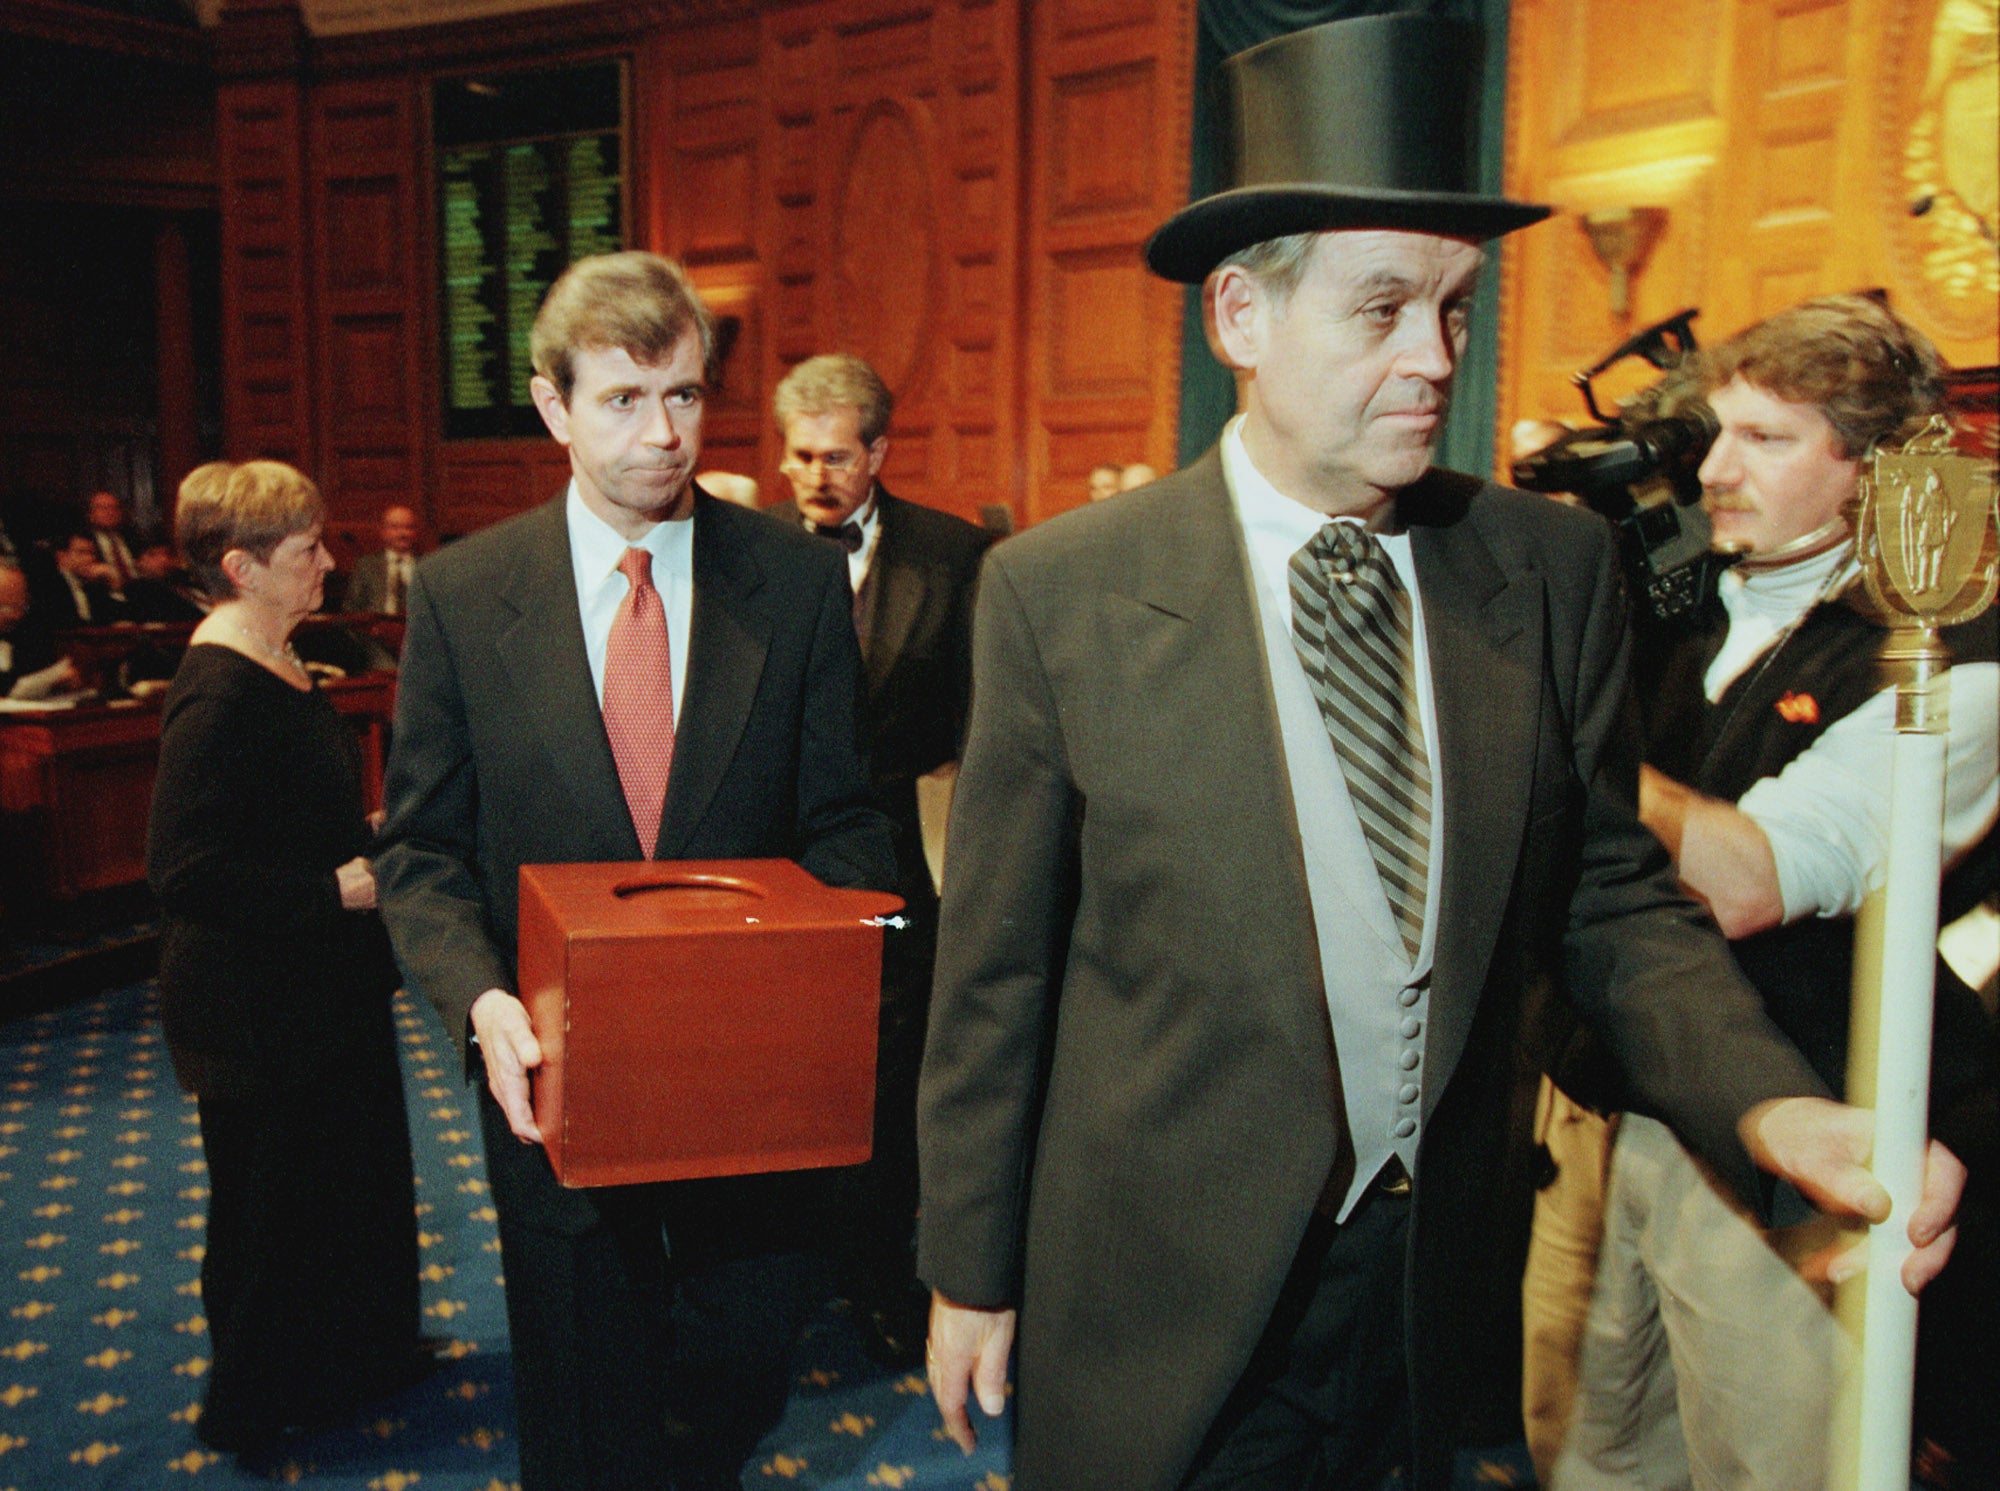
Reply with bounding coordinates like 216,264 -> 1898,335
1500,0 -> 2000,453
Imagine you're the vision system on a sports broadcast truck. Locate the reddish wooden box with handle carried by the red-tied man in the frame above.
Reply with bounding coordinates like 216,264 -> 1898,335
518,859 -> 902,1185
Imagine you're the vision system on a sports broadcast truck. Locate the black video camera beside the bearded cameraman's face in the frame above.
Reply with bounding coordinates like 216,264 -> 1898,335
1514,310 -> 1732,622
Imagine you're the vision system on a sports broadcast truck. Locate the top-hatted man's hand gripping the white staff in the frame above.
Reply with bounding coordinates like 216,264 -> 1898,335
1738,1097 -> 1966,1295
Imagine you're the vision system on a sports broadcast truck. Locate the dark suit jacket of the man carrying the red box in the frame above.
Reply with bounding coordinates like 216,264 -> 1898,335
376,494 -> 894,1079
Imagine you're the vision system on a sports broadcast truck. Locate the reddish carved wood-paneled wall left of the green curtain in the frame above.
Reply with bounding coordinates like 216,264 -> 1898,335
218,0 -> 1194,550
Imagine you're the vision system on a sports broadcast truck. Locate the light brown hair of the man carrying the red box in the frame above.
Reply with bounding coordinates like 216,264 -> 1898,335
528,250 -> 716,404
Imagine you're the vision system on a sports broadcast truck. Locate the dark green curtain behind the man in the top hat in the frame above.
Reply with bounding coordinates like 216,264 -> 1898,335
1180,0 -> 1508,476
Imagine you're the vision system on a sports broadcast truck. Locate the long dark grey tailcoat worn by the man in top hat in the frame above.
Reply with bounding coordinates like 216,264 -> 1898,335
918,454 -> 1818,1491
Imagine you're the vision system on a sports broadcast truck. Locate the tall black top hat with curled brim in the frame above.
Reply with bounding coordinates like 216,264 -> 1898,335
1146,14 -> 1550,284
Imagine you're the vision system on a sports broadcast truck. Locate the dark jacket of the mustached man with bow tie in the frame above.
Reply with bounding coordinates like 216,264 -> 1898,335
780,488 -> 992,909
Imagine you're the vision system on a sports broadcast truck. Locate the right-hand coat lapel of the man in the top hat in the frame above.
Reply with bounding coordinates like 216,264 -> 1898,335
1406,481 -> 1544,1095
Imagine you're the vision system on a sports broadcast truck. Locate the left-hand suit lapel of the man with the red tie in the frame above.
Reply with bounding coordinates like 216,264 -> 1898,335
494,498 -> 638,857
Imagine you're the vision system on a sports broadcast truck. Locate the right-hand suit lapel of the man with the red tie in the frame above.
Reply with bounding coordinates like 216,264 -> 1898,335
656,492 -> 770,859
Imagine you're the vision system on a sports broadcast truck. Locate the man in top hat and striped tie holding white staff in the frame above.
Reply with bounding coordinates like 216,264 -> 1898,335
918,16 -> 1962,1491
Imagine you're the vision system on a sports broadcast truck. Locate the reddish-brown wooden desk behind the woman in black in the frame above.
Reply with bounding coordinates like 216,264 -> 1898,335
0,674 -> 396,899
